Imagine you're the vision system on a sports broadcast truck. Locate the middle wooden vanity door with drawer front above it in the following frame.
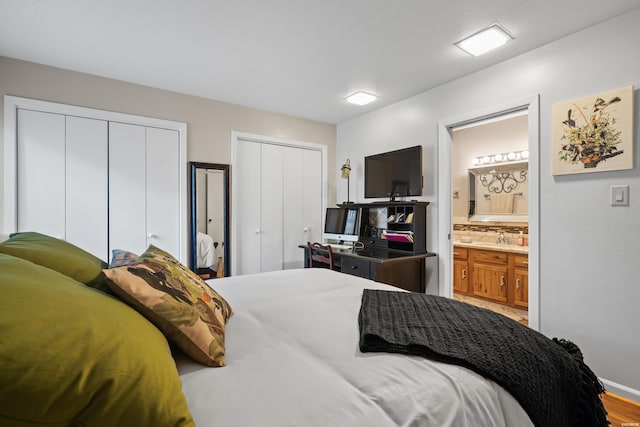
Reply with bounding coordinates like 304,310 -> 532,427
469,249 -> 509,304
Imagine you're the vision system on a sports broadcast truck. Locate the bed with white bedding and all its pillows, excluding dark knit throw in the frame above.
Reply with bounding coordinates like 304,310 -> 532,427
0,233 -> 608,427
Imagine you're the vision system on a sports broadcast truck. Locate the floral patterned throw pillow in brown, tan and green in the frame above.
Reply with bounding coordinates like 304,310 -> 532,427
104,245 -> 233,366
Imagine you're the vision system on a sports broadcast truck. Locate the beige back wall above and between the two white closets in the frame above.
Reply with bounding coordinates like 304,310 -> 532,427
0,56 -> 339,229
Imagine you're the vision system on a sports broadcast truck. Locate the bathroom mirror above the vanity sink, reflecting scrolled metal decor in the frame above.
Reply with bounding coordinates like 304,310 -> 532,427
469,162 -> 529,222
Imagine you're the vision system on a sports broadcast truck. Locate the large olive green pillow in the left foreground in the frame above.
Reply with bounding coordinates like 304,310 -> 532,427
0,254 -> 194,427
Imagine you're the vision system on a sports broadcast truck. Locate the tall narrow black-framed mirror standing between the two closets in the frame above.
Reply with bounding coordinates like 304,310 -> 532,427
189,162 -> 231,279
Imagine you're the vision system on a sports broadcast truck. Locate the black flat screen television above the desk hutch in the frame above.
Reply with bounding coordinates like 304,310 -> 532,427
364,145 -> 422,201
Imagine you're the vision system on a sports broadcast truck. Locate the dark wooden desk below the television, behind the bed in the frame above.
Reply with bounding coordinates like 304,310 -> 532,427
298,245 -> 435,293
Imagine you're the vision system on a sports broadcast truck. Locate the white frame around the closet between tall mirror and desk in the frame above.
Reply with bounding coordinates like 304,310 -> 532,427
230,131 -> 327,276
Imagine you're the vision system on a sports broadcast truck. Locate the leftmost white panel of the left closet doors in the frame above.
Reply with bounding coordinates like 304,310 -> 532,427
17,109 -> 65,239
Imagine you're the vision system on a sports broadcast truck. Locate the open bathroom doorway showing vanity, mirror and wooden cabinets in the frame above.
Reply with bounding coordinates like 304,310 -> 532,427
451,109 -> 529,325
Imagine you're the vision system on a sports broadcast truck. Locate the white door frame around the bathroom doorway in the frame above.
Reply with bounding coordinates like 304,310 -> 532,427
438,94 -> 540,330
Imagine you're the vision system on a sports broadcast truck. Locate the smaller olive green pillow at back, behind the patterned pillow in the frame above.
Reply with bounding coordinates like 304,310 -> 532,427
0,231 -> 109,291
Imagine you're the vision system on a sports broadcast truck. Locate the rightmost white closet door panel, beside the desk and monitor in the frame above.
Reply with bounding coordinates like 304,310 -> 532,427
298,150 -> 323,246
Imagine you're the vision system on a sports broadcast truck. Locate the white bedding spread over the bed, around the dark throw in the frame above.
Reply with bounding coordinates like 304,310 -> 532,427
177,269 -> 533,427
